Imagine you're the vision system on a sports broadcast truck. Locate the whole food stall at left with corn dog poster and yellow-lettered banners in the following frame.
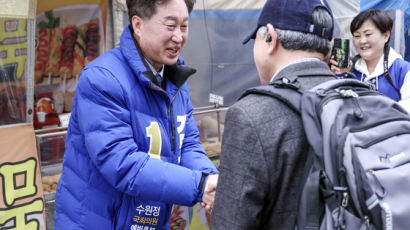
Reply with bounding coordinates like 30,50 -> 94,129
0,0 -> 113,229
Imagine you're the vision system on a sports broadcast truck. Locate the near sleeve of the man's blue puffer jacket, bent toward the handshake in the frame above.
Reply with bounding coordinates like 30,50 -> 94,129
76,68 -> 207,205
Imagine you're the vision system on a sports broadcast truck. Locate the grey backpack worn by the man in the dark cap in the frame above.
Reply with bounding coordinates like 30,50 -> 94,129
242,76 -> 410,230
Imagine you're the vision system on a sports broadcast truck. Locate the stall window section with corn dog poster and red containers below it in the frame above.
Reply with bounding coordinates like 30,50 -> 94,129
33,0 -> 108,129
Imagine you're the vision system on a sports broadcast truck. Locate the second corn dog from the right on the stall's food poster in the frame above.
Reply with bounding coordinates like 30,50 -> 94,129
73,24 -> 87,76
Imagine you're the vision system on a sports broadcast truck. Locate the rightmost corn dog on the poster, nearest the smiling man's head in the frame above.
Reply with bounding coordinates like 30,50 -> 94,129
85,18 -> 100,65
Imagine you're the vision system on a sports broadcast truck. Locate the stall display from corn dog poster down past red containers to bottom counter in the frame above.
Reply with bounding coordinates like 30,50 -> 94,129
30,0 -> 114,227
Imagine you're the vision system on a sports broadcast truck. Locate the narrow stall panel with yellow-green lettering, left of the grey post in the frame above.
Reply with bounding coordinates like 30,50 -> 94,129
0,18 -> 28,125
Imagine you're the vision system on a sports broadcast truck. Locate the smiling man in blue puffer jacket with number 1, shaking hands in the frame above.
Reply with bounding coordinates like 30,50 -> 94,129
54,0 -> 221,230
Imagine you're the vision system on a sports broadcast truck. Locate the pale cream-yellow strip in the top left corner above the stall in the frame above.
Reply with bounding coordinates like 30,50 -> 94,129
0,0 -> 36,19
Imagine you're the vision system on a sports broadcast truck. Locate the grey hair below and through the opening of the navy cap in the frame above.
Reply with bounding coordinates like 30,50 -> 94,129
275,7 -> 333,56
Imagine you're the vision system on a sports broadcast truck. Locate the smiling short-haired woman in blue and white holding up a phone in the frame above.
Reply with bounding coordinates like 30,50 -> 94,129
330,9 -> 410,111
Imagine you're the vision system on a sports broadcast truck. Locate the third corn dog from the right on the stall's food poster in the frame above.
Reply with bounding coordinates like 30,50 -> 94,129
59,25 -> 77,79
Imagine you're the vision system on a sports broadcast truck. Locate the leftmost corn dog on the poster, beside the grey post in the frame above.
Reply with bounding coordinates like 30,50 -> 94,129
34,28 -> 50,82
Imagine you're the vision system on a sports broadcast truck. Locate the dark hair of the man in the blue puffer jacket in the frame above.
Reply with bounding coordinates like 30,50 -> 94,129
127,0 -> 196,22
